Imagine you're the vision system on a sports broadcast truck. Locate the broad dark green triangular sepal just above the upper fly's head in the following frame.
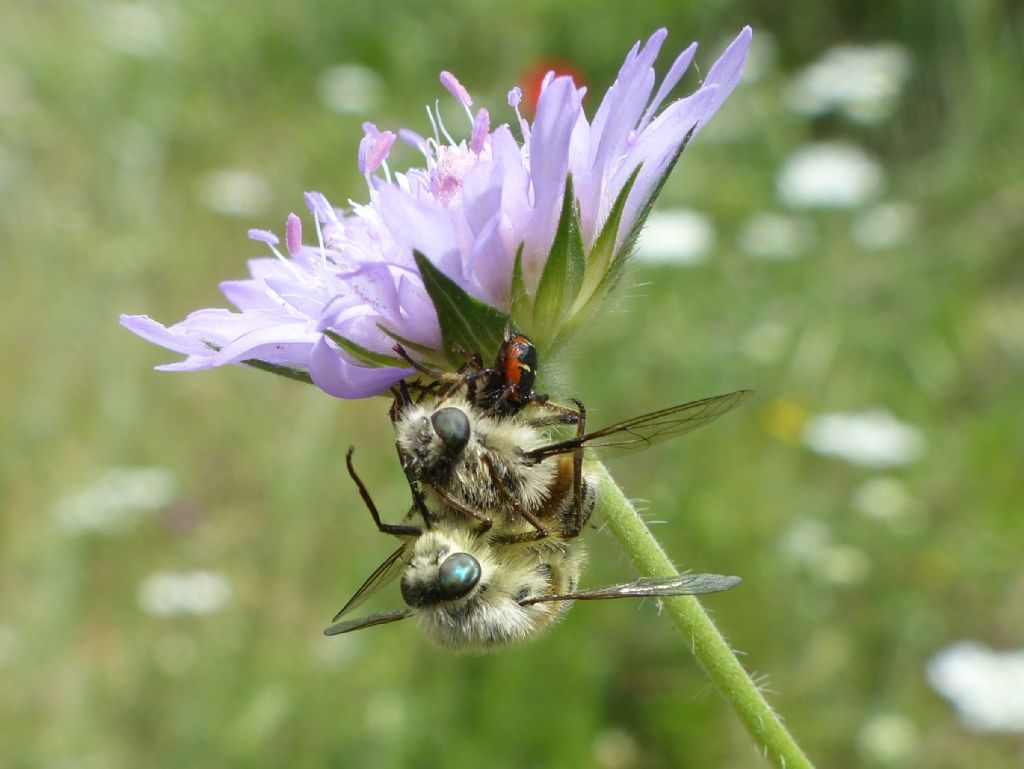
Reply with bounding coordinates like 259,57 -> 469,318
413,251 -> 509,368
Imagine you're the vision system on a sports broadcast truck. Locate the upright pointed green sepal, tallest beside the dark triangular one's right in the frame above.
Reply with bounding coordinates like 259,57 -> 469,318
534,174 -> 587,340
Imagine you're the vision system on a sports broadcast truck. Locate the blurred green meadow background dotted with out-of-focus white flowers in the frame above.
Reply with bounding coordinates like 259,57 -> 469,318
0,0 -> 1024,769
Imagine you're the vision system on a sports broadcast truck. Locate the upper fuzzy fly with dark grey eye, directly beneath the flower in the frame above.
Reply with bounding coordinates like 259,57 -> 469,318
391,390 -> 752,539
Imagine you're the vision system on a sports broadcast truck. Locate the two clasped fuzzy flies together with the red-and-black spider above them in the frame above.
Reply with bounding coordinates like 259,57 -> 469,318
326,329 -> 751,651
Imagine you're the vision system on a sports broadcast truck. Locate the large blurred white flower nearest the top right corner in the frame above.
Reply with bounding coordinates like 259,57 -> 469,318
785,43 -> 910,123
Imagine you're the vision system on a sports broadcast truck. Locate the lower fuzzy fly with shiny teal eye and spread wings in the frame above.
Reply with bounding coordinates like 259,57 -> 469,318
325,466 -> 740,653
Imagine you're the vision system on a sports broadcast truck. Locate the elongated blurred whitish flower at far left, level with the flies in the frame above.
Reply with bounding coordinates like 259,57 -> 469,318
51,467 -> 178,533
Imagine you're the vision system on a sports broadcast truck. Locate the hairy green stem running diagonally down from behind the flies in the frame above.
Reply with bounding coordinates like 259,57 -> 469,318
588,462 -> 813,769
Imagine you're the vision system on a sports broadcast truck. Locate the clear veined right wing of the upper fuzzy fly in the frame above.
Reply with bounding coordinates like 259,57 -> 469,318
526,390 -> 754,461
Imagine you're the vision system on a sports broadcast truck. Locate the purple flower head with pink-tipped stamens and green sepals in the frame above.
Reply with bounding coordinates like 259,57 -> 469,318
121,28 -> 751,397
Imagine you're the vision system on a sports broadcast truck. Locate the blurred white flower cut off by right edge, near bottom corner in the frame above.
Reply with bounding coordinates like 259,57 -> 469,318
926,641 -> 1024,732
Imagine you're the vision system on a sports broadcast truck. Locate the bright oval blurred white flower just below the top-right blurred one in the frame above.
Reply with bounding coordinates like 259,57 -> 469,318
775,141 -> 885,208
